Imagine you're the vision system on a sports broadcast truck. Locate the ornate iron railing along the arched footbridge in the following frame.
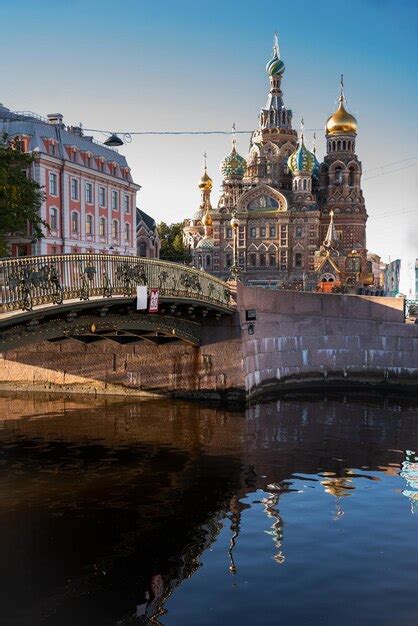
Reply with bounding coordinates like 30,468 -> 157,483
0,254 -> 231,313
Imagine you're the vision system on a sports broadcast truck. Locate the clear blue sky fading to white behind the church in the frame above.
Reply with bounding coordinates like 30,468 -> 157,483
0,0 -> 418,295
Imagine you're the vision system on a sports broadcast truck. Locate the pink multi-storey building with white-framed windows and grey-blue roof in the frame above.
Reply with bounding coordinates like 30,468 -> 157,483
0,104 -> 140,256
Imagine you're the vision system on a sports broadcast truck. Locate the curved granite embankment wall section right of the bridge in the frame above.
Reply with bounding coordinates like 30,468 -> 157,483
238,286 -> 418,395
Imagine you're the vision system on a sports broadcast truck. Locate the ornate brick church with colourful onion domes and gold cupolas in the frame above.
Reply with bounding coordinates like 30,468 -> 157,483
184,33 -> 370,291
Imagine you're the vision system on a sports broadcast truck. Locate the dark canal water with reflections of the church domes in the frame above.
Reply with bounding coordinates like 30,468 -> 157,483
0,395 -> 418,626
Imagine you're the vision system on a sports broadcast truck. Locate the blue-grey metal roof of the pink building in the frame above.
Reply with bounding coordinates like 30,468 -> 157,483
0,104 -> 128,167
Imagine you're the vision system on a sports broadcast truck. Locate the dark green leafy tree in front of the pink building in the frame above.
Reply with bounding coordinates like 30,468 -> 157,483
0,136 -> 48,256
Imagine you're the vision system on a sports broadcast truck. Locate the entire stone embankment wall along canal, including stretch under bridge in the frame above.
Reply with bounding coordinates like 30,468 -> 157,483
0,285 -> 418,398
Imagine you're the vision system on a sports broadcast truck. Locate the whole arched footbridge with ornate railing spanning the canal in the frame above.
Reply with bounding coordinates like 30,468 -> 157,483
0,254 -> 234,349
